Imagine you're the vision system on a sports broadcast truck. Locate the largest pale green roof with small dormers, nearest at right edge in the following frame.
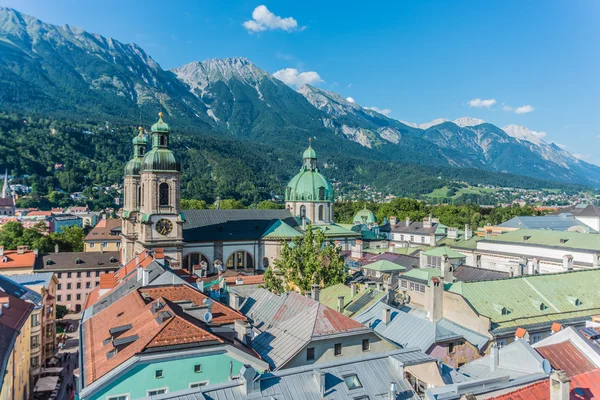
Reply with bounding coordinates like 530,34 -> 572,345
448,269 -> 600,330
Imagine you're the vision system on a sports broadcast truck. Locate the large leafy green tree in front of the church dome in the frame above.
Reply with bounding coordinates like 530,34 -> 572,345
265,225 -> 346,293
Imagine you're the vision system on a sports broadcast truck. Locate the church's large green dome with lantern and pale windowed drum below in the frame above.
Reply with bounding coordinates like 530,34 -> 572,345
285,145 -> 334,225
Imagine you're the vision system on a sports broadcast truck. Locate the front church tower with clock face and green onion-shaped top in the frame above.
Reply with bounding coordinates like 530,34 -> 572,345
124,113 -> 184,267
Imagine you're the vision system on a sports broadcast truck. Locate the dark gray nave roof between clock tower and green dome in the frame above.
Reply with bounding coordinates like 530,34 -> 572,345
183,210 -> 299,242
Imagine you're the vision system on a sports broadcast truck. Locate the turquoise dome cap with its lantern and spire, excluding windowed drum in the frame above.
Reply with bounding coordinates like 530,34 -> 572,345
285,147 -> 334,203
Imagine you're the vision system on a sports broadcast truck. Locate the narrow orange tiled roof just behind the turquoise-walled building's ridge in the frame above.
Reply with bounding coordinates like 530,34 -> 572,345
139,285 -> 247,325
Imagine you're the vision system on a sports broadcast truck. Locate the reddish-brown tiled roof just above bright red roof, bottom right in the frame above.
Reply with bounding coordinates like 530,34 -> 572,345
536,340 -> 596,376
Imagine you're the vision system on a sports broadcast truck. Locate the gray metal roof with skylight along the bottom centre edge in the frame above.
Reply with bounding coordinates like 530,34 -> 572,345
153,349 -> 434,400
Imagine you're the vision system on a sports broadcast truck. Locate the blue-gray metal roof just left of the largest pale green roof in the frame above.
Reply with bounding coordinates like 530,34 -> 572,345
354,302 -> 489,352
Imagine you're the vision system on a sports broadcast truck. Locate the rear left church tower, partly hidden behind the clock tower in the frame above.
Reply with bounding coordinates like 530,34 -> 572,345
121,126 -> 148,263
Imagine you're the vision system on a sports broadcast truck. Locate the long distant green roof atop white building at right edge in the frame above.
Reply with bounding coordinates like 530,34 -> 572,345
483,229 -> 600,252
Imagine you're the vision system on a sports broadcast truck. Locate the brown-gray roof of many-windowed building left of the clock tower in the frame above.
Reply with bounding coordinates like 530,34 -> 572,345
35,251 -> 121,271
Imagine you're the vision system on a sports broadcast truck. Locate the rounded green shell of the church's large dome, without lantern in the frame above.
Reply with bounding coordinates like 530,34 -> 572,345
285,170 -> 334,202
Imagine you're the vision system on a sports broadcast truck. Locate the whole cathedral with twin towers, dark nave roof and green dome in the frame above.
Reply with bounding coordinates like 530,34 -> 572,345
121,113 -> 360,273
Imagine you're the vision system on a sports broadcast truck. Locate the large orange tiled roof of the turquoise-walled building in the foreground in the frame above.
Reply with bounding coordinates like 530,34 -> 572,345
84,291 -> 223,385
